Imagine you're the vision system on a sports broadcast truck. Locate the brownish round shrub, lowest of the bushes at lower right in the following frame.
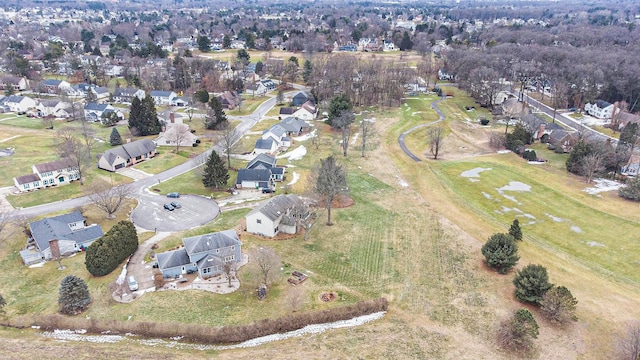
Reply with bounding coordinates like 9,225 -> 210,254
498,309 -> 539,352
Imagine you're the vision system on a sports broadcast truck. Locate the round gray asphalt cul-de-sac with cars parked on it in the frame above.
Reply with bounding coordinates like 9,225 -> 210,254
131,193 -> 220,232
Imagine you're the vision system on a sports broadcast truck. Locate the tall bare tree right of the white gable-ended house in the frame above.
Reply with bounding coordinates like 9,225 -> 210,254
310,156 -> 349,225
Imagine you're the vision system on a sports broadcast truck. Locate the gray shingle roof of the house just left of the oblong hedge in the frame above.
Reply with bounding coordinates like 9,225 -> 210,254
29,211 -> 103,251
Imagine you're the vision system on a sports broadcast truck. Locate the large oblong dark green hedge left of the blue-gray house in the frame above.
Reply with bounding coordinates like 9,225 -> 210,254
84,220 -> 138,276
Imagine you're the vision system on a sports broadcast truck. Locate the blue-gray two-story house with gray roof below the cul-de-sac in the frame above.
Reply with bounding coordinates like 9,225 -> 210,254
156,230 -> 242,279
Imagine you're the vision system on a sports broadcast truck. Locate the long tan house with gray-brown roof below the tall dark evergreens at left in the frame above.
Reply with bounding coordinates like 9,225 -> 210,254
97,139 -> 157,171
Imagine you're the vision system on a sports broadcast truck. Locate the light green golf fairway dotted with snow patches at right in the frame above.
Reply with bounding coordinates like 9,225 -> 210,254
434,158 -> 640,282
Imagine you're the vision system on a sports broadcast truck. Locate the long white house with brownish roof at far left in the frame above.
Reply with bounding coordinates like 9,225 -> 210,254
13,159 -> 80,192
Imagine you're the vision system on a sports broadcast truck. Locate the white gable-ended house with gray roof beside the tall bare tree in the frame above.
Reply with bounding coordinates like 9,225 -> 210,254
245,194 -> 308,237
